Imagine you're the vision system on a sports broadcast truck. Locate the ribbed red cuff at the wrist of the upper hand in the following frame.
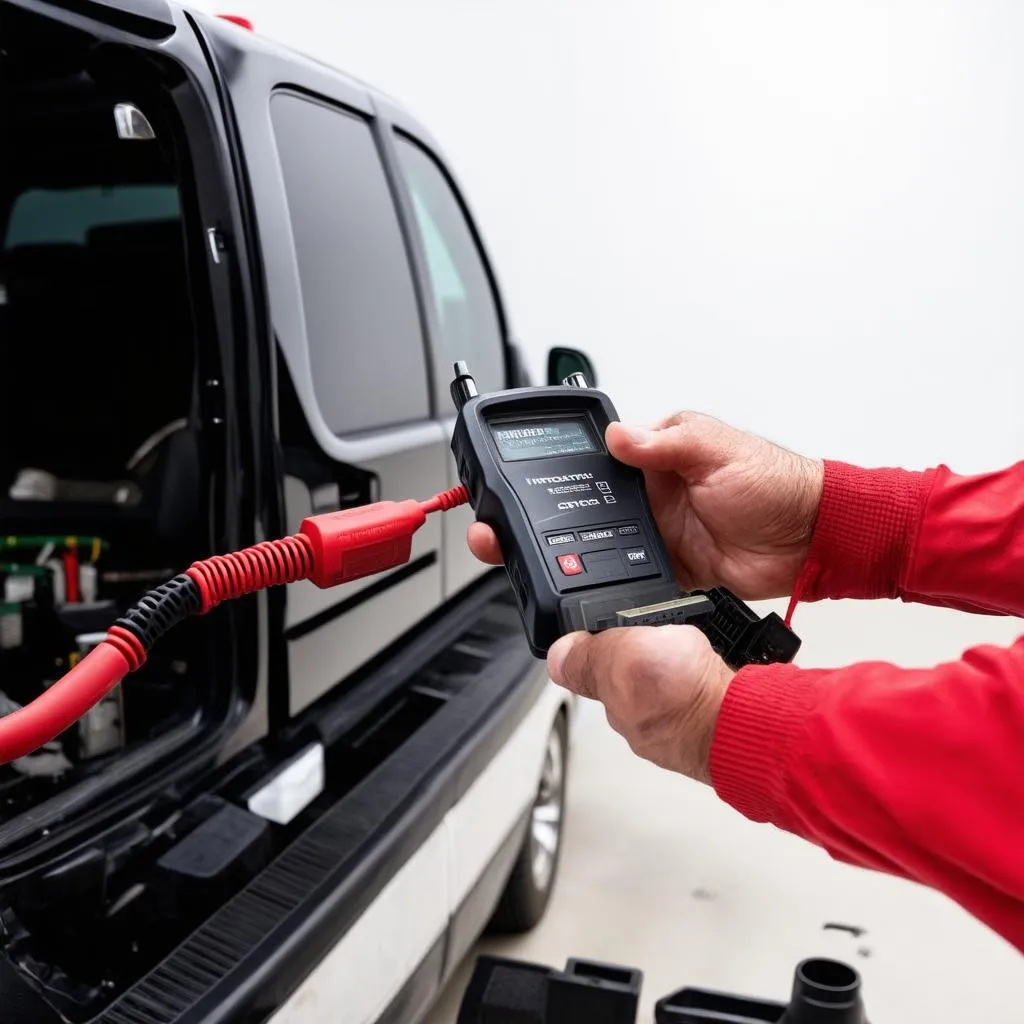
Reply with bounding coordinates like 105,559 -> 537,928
796,461 -> 935,601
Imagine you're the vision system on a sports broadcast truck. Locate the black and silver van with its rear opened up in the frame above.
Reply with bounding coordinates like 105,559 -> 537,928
0,0 -> 592,1024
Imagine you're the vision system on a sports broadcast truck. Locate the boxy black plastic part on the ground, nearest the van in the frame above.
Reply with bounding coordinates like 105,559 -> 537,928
458,956 -> 643,1024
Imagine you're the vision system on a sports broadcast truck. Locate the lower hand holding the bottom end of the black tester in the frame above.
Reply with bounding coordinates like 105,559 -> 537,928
548,626 -> 734,783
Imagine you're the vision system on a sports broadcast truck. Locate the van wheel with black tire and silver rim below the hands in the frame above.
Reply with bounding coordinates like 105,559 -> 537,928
487,712 -> 568,935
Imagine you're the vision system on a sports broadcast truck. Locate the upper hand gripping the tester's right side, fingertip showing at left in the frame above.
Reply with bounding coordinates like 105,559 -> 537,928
469,413 -> 824,600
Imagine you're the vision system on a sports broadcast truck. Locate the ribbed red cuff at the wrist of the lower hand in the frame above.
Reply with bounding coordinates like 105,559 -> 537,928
711,665 -> 819,828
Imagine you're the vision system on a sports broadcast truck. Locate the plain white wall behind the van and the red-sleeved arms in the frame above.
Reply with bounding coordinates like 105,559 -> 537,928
203,0 -> 1024,662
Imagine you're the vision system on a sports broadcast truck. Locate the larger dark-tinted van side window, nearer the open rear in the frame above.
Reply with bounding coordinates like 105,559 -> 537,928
270,93 -> 428,434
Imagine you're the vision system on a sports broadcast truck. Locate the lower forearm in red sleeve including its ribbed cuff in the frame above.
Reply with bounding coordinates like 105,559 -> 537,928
711,638 -> 1024,949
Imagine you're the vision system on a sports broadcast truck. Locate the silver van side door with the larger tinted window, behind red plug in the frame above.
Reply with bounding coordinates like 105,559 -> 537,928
193,19 -> 447,720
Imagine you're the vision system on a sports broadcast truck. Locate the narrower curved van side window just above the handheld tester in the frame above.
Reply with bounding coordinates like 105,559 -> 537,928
396,136 -> 505,403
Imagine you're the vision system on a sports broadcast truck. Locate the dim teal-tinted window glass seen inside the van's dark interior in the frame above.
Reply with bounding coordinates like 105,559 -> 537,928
4,184 -> 180,249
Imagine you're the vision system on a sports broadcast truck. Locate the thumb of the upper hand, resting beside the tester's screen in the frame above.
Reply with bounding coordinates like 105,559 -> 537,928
605,417 -> 728,479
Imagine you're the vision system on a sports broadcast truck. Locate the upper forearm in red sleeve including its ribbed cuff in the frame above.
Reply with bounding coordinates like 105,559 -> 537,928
795,462 -> 1024,615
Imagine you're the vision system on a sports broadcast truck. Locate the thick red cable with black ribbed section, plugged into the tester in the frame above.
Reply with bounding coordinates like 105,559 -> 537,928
0,487 -> 469,764
